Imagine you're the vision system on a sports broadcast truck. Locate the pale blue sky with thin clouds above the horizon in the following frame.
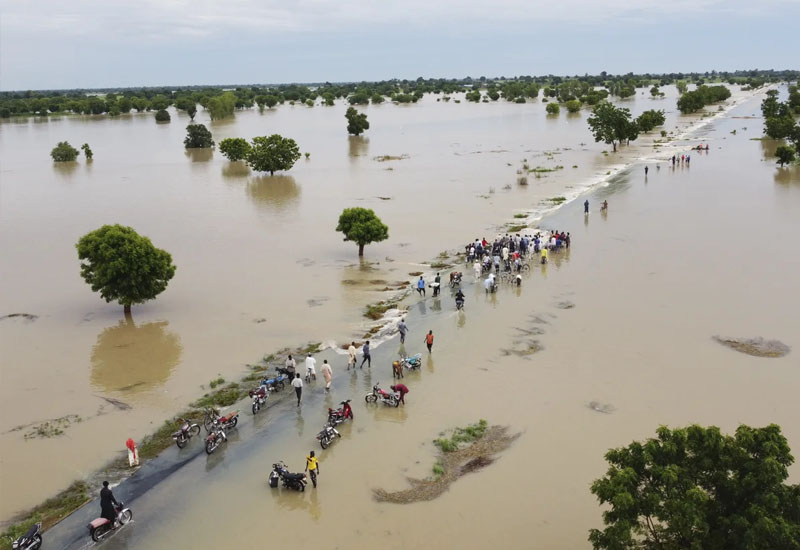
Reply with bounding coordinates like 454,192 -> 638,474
0,0 -> 800,90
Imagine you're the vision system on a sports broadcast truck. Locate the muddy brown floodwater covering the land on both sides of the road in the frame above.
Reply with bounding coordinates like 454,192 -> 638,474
0,86 -> 800,548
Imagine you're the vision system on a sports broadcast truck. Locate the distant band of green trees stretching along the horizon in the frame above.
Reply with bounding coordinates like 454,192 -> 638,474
0,70 -> 800,119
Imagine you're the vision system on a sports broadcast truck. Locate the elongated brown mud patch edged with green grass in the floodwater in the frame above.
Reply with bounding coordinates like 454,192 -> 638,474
372,426 -> 520,504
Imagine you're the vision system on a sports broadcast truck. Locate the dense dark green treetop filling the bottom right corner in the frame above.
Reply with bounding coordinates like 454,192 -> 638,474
589,424 -> 800,550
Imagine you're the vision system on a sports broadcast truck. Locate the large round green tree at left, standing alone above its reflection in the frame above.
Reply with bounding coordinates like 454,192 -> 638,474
75,225 -> 175,314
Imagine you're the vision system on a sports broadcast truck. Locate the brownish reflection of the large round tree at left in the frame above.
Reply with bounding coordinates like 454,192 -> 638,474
91,320 -> 183,391
